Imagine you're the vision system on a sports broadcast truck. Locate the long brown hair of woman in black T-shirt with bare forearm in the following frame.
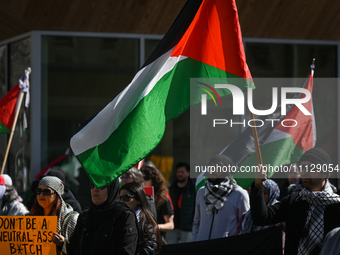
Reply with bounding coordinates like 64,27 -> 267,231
141,165 -> 168,209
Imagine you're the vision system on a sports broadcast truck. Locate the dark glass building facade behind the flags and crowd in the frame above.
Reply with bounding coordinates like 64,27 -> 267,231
0,31 -> 339,192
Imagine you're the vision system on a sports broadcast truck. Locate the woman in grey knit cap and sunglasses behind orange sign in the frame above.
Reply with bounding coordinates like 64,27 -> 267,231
30,176 -> 79,252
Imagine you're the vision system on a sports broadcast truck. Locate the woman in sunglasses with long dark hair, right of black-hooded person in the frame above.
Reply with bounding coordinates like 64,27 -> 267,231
120,182 -> 161,255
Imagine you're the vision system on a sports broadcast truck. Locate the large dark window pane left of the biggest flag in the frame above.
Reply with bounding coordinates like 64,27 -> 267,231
42,36 -> 139,171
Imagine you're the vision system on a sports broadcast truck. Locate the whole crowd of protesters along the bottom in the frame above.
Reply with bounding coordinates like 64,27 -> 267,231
0,145 -> 340,255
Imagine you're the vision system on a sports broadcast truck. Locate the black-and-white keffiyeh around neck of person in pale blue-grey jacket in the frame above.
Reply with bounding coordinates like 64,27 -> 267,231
204,178 -> 236,215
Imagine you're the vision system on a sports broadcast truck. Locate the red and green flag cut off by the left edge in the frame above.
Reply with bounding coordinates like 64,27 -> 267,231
0,84 -> 20,134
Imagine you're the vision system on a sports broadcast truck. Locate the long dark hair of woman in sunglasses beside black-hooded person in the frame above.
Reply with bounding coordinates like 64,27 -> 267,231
120,182 -> 162,252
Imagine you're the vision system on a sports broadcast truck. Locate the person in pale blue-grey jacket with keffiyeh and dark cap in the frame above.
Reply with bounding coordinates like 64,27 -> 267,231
192,155 -> 250,241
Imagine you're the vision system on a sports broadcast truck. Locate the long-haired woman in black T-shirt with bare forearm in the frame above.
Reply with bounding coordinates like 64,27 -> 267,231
141,165 -> 174,239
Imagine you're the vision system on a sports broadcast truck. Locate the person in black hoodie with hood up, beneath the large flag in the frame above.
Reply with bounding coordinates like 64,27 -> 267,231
67,180 -> 139,255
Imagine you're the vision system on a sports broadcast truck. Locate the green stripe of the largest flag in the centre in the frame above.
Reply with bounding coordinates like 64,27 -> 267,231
77,58 -> 254,187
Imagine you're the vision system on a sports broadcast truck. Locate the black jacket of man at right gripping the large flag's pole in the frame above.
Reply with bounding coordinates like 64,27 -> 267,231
250,183 -> 340,255
